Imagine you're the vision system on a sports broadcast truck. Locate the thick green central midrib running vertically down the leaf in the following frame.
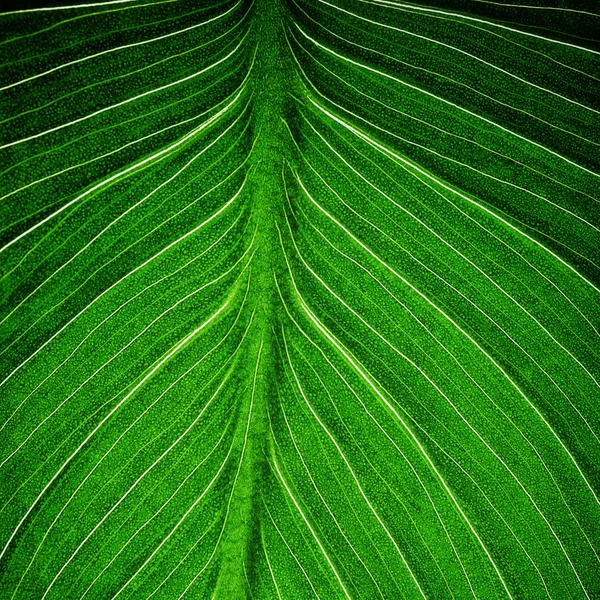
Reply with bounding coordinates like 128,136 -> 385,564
214,0 -> 294,600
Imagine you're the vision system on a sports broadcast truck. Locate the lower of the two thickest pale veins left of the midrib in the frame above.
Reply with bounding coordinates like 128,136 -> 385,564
0,298 -> 231,560
